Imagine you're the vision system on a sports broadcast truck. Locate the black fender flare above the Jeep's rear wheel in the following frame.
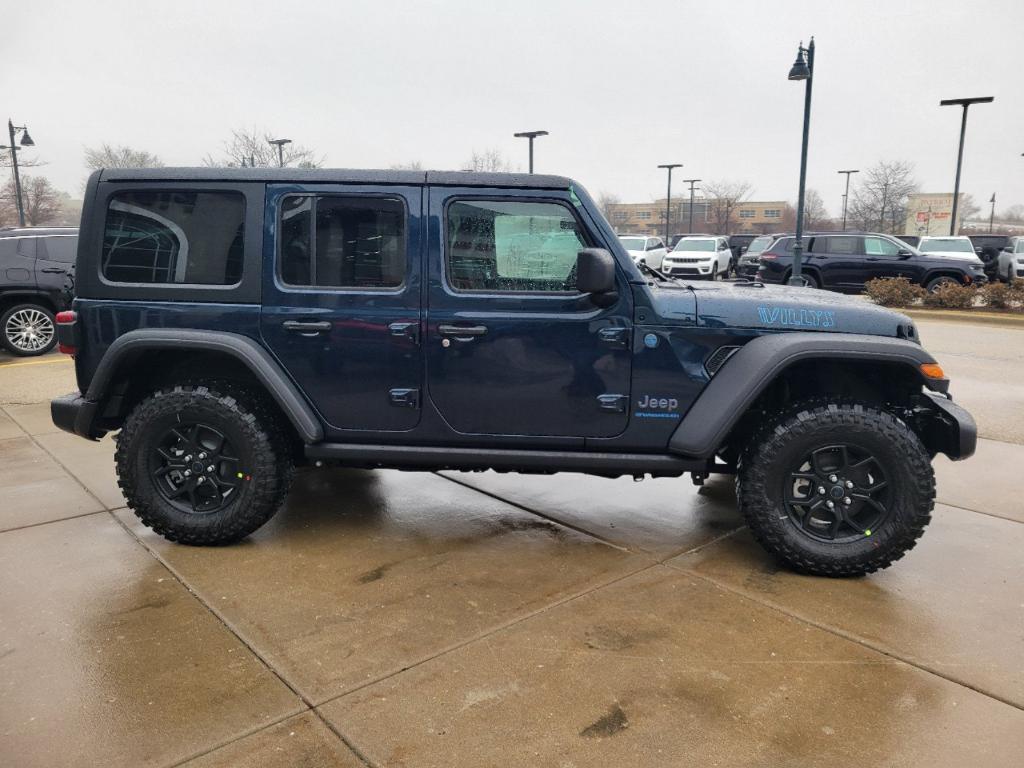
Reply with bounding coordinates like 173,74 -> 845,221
85,328 -> 324,443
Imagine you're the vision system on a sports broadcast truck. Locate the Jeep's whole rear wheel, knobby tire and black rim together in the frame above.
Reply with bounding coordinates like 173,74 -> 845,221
116,383 -> 293,545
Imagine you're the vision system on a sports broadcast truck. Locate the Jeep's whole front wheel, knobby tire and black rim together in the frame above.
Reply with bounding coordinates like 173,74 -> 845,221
736,400 -> 935,577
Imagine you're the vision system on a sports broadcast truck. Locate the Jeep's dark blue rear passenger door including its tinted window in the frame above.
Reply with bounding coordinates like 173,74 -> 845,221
260,184 -> 423,432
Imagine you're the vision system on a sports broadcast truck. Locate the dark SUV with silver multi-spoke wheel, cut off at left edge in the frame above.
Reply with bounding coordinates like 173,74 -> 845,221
0,227 -> 78,356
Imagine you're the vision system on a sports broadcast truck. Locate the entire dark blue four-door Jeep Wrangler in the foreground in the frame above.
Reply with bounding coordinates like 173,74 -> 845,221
51,168 -> 976,575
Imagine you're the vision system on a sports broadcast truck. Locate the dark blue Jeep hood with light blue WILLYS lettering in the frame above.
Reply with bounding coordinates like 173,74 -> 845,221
651,283 -> 916,338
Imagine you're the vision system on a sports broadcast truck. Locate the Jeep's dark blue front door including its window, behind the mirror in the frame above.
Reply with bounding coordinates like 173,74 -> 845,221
424,187 -> 632,438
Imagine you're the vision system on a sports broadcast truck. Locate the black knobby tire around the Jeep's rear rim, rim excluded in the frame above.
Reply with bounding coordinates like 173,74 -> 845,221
115,382 -> 294,546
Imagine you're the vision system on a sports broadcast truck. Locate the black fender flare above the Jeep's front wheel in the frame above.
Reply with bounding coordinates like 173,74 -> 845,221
669,331 -> 949,459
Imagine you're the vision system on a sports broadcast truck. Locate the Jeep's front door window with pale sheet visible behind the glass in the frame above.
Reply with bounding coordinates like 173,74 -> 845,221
446,201 -> 587,292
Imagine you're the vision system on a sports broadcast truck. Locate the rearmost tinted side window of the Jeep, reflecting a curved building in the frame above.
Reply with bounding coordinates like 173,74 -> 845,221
101,189 -> 246,286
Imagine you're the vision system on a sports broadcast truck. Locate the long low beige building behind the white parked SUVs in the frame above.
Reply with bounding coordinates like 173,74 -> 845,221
607,197 -> 786,236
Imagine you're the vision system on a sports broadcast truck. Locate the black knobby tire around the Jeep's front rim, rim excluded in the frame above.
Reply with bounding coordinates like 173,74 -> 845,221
736,398 -> 935,577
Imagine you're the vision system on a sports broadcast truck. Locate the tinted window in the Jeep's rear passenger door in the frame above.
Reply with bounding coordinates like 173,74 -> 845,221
281,197 -> 406,288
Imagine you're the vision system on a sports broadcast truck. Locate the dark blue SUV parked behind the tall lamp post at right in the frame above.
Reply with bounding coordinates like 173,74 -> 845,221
757,232 -> 987,293
